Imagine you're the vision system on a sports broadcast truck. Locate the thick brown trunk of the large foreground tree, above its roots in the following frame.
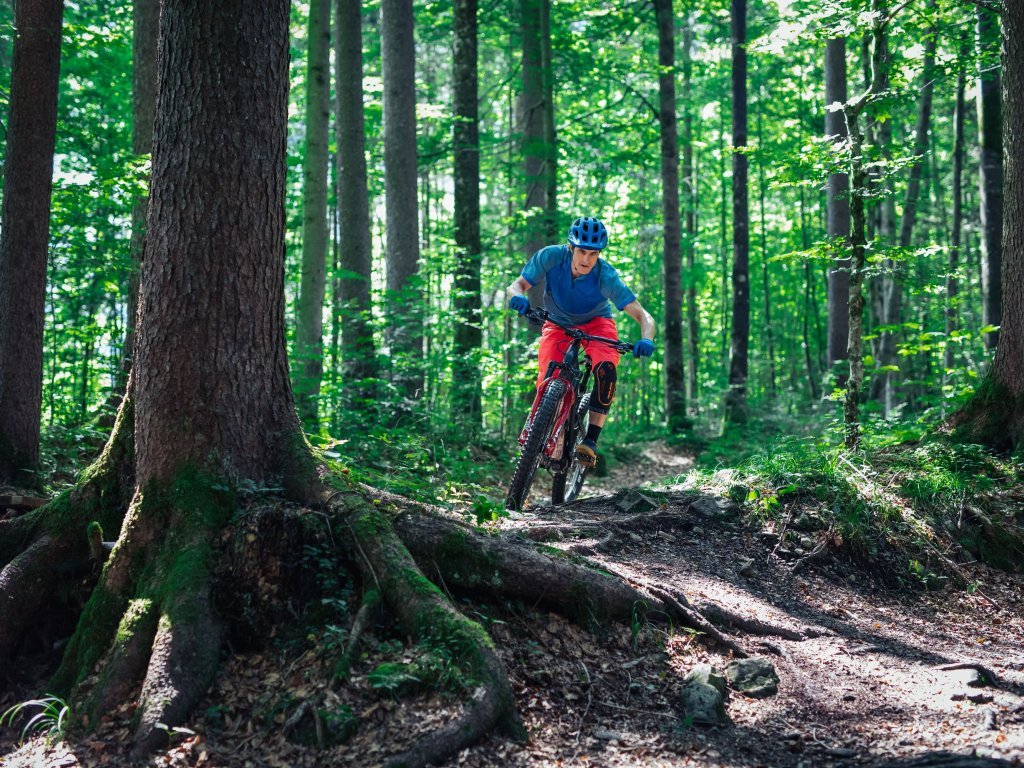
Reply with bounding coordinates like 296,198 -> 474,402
135,0 -> 297,487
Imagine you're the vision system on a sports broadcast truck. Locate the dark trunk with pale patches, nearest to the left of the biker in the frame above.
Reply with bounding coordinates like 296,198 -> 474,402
452,0 -> 483,429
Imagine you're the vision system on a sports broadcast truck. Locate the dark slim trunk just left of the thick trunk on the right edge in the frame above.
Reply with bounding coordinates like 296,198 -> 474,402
978,6 -> 1010,349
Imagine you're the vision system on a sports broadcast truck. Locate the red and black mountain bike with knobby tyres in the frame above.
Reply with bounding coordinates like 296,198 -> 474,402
505,308 -> 633,510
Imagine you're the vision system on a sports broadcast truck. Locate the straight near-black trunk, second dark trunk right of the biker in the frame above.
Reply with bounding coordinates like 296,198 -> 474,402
726,0 -> 751,422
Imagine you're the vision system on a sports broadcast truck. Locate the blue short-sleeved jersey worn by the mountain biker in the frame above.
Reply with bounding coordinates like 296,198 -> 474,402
522,246 -> 637,326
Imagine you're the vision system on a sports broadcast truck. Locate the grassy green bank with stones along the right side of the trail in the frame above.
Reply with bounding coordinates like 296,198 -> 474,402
676,437 -> 1024,588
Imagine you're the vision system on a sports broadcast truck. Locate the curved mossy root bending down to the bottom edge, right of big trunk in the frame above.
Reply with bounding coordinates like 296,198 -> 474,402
323,493 -> 521,768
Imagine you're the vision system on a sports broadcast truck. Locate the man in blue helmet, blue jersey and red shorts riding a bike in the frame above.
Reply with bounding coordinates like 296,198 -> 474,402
506,216 -> 654,467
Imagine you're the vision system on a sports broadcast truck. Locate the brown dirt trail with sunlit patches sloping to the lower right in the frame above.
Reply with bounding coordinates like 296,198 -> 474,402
479,489 -> 1024,766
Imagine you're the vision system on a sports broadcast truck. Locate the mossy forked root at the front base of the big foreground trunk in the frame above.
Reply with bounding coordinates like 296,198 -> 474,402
53,471 -> 233,757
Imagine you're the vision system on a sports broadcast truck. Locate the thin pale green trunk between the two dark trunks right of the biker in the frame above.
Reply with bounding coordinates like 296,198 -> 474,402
683,16 -> 700,410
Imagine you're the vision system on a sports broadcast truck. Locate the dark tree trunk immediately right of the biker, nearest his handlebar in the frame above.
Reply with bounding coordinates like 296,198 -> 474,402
654,0 -> 686,432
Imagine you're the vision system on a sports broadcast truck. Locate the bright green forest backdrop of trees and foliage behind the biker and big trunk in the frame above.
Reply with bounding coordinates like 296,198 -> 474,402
0,0 -> 1002,511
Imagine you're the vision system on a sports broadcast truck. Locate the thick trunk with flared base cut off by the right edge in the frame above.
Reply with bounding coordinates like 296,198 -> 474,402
948,2 -> 1024,450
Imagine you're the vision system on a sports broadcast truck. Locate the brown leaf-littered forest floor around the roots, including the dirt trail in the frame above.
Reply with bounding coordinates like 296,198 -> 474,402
0,443 -> 1024,768
